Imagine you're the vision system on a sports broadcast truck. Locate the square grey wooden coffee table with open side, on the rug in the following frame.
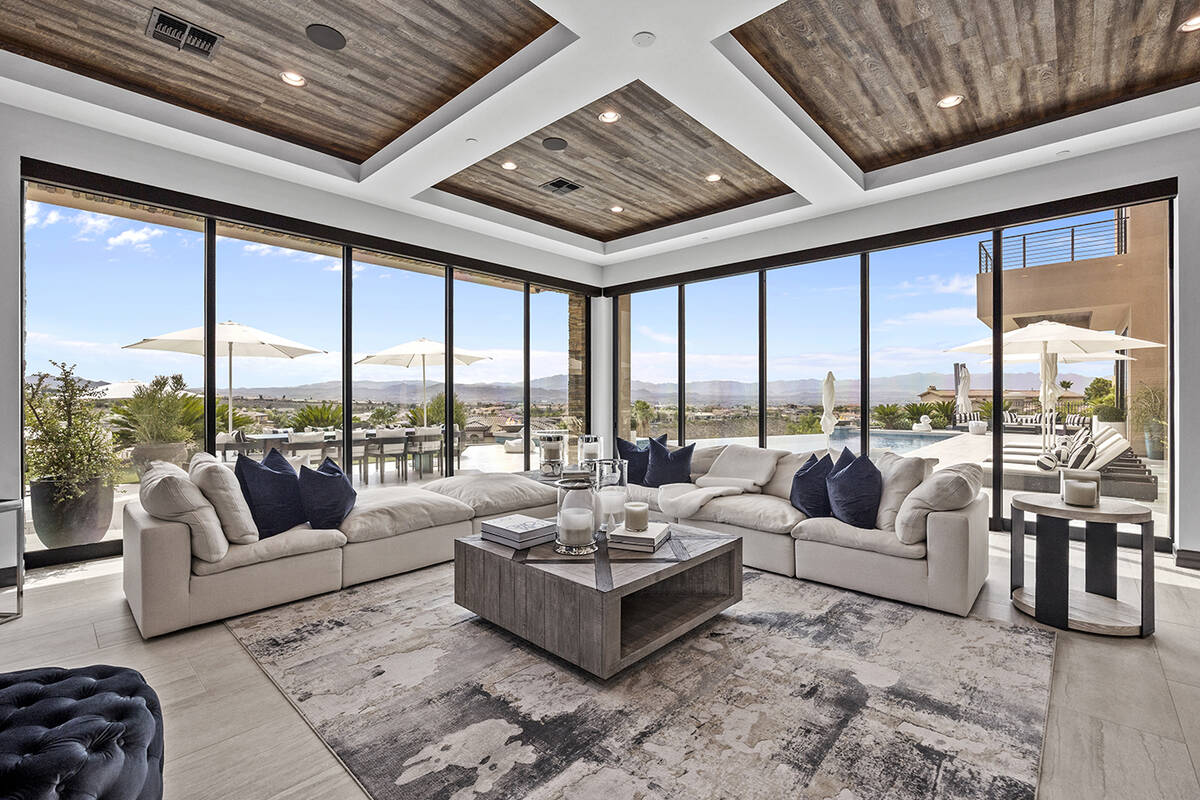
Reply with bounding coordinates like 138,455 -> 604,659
454,525 -> 742,678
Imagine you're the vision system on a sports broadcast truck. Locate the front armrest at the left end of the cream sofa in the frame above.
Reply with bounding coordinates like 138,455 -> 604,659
122,503 -> 192,638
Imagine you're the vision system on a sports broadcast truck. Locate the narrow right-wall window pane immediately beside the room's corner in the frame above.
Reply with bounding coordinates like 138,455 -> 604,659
616,287 -> 679,443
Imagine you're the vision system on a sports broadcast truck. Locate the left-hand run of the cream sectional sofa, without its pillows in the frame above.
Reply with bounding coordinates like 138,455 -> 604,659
124,475 -> 557,638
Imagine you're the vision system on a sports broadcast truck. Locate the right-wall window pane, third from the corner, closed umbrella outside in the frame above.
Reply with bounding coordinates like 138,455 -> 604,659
766,255 -> 862,452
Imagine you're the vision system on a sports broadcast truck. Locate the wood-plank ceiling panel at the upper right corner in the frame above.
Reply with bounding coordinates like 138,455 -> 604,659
732,0 -> 1200,170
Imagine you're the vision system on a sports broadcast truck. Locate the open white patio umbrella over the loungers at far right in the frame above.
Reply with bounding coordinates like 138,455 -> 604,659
949,319 -> 1165,447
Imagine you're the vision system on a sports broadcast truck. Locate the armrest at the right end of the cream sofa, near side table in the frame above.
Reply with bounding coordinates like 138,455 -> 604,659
925,492 -> 990,616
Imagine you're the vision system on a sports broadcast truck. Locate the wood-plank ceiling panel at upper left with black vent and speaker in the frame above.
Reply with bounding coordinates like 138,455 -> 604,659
0,0 -> 554,162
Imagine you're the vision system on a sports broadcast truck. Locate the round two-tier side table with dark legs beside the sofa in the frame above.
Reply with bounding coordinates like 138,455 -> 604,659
1010,493 -> 1154,637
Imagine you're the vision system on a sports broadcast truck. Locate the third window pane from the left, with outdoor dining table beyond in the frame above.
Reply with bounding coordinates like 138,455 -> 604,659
350,249 -> 446,485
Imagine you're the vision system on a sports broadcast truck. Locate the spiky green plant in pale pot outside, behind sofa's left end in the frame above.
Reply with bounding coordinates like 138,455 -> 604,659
114,375 -> 203,475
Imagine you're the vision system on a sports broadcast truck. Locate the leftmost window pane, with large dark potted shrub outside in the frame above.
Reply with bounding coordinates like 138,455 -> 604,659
24,182 -> 204,552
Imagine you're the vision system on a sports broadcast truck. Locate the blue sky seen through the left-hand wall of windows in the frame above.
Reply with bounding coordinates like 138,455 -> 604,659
25,196 -> 568,387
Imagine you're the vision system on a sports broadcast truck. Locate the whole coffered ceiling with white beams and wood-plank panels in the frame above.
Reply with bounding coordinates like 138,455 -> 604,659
0,0 -> 1200,264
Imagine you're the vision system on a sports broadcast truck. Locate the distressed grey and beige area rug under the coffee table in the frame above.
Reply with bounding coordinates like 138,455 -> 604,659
228,565 -> 1055,800
